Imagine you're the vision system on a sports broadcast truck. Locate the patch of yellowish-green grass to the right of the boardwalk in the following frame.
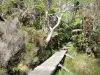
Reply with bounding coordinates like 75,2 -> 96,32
55,45 -> 100,75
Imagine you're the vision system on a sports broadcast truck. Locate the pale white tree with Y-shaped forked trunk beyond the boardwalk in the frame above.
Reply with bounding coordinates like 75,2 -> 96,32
45,0 -> 62,44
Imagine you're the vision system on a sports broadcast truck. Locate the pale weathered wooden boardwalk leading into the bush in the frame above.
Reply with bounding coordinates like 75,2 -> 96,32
28,50 -> 67,75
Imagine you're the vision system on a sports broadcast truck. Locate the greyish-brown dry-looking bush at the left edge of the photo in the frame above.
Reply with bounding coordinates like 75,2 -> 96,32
0,18 -> 24,68
